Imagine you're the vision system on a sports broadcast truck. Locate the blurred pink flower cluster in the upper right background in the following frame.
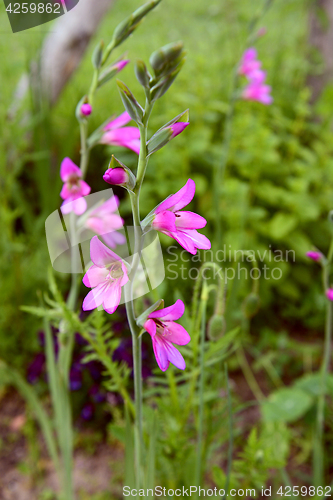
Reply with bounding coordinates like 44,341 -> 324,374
238,47 -> 273,105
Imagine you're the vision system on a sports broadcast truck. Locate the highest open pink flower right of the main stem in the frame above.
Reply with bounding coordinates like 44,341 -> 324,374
152,179 -> 211,255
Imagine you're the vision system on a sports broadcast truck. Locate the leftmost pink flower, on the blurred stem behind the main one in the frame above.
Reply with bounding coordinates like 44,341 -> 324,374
60,158 -> 91,215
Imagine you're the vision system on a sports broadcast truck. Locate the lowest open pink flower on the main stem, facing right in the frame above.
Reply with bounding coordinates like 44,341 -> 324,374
144,300 -> 191,372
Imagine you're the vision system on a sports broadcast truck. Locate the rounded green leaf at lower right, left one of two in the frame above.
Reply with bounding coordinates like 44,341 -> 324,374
261,387 -> 314,422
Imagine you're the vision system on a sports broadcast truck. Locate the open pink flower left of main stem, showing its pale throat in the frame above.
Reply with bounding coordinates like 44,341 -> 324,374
82,236 -> 128,314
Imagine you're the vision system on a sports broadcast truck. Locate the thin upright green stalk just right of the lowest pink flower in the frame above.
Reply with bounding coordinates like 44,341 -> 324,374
195,283 -> 208,488
